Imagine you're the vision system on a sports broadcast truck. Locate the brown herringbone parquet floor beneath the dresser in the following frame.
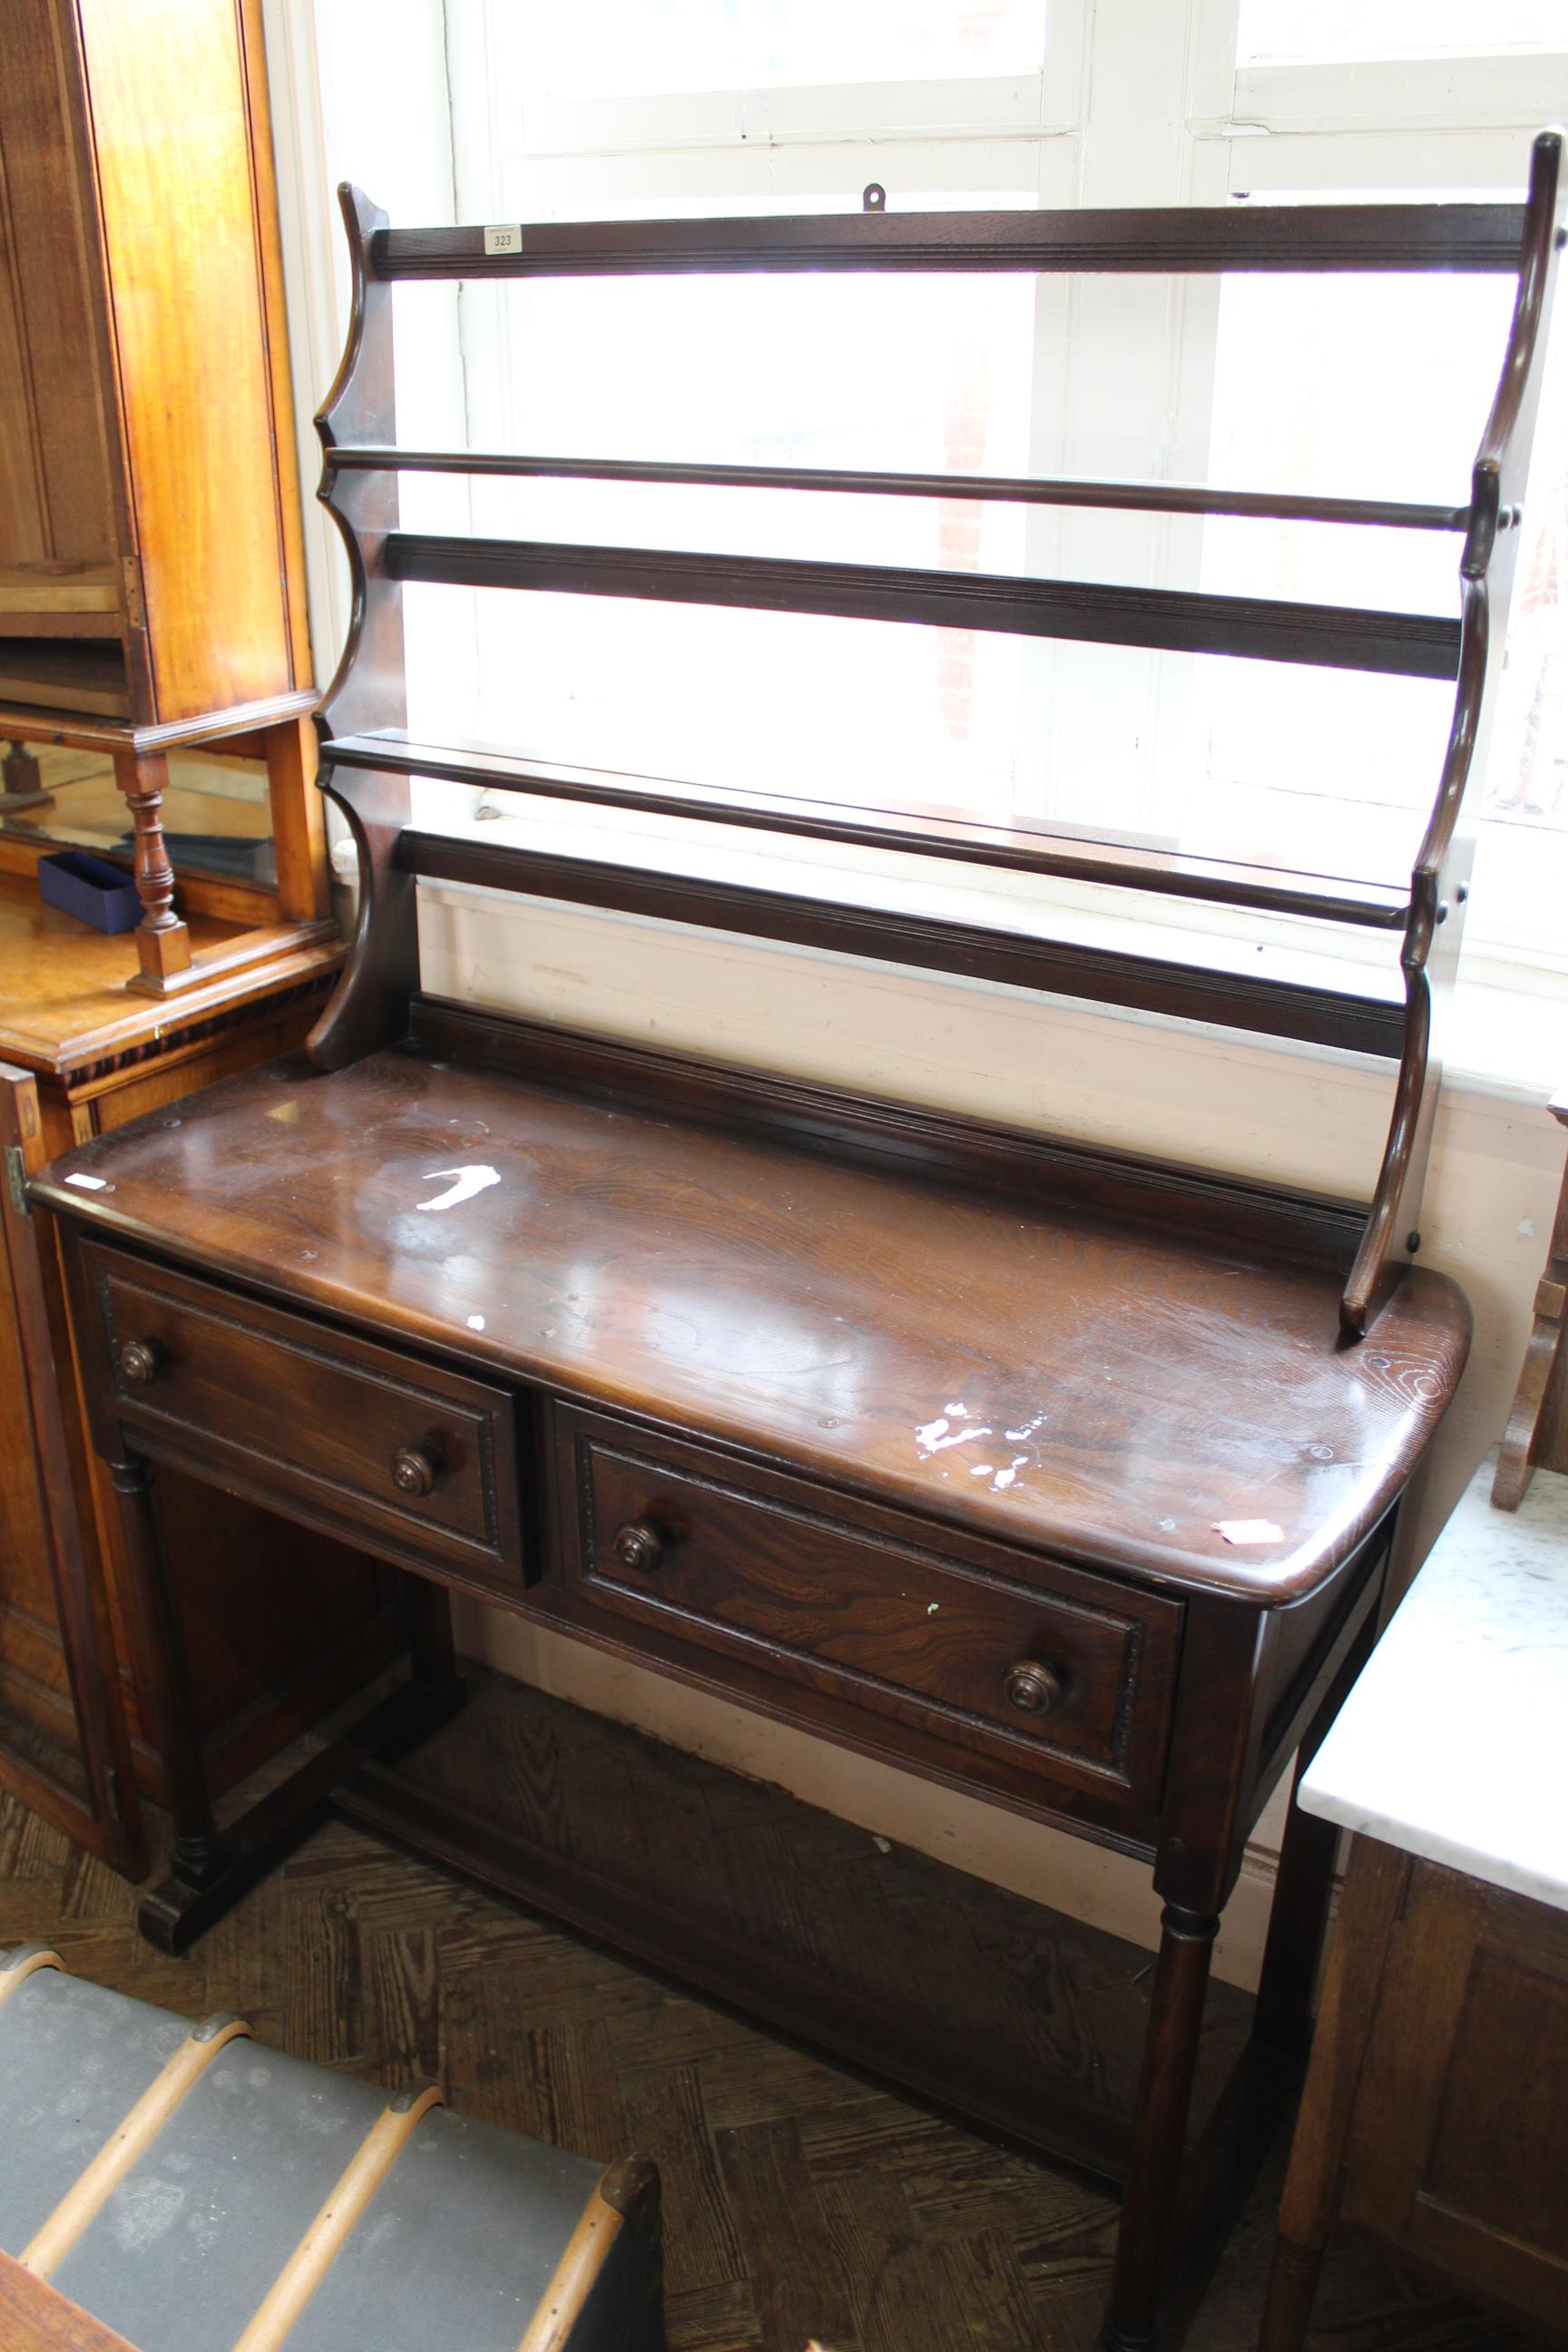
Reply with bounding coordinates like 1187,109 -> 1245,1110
0,1769 -> 1516,2352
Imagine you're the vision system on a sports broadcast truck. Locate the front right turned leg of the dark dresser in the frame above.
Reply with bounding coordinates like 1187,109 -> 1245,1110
1100,1903 -> 1220,2352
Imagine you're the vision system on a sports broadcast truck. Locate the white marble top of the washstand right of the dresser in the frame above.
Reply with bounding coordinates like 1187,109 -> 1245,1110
1300,1454 -> 1568,1910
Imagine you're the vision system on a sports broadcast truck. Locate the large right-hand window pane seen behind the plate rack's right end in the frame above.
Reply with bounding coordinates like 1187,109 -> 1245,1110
1199,220 -> 1568,962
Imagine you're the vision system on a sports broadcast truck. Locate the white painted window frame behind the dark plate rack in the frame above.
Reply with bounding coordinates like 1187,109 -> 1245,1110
263,0 -> 1568,1077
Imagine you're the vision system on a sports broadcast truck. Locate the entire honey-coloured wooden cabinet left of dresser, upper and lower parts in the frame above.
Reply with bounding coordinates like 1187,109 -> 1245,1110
0,0 -> 397,1872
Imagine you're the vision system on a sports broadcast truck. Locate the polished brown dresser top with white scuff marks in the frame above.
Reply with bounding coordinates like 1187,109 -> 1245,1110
35,1052 -> 1469,1602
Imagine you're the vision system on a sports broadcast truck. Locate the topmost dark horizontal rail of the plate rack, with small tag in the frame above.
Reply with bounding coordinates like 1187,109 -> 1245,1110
371,205 -> 1524,278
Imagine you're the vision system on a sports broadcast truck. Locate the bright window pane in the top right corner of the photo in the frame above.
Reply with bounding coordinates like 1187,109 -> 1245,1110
1237,0 -> 1568,66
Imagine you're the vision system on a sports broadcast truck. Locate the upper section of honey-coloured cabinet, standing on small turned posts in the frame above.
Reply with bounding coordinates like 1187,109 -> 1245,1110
0,0 -> 327,995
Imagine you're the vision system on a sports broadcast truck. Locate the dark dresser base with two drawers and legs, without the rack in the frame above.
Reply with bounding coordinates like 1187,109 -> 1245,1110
35,1004 -> 1469,2343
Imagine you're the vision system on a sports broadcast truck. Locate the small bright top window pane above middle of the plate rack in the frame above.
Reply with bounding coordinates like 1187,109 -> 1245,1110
513,0 -> 1046,99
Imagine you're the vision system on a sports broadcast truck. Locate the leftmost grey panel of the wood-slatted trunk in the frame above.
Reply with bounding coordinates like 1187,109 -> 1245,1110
0,1969 -> 191,2256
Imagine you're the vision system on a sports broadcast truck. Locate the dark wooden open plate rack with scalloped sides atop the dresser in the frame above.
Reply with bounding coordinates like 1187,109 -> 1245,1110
310,130 -> 1568,1340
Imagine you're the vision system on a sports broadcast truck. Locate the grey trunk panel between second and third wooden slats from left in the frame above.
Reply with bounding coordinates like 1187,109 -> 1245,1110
52,2042 -> 387,2352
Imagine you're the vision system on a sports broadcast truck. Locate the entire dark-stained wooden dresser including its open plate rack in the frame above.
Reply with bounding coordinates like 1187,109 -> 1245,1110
33,147 -> 1563,2352
